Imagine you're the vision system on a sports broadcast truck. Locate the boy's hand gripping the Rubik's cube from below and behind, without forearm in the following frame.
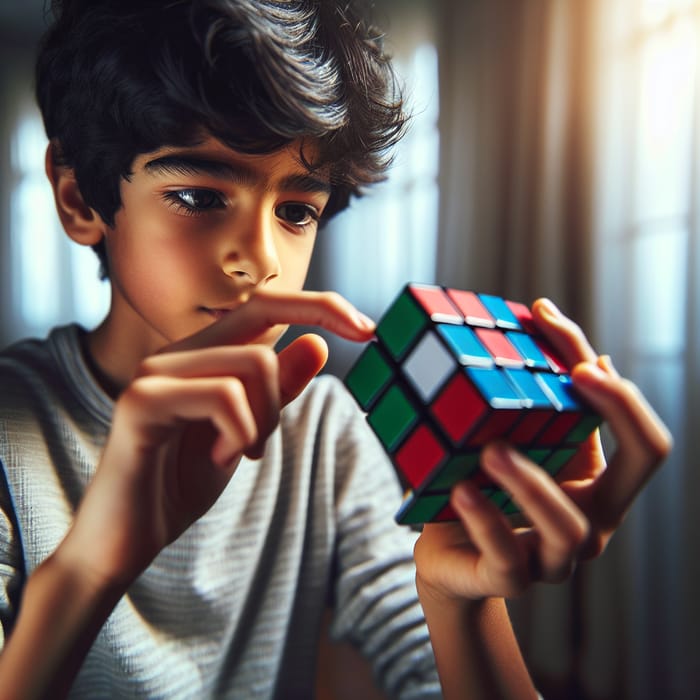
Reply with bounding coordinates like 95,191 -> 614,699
415,300 -> 672,600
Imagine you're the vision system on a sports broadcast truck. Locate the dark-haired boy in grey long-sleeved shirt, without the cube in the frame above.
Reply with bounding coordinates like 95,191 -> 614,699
0,0 -> 670,698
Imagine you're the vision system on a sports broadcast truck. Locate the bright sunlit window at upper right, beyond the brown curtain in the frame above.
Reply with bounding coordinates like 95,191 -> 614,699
599,0 -> 700,392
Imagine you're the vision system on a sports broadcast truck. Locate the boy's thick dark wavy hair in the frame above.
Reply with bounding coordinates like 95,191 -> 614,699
36,0 -> 406,273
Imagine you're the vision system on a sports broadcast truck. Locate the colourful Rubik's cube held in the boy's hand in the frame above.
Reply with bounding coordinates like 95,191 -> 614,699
345,284 -> 601,524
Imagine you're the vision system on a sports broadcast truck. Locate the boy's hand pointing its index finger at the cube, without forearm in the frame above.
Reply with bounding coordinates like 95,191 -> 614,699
60,292 -> 373,586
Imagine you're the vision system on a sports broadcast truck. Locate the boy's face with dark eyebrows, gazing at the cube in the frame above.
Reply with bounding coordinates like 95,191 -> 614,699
98,138 -> 330,357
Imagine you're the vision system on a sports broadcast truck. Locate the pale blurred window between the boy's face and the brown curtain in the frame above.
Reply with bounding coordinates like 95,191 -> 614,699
307,15 -> 439,376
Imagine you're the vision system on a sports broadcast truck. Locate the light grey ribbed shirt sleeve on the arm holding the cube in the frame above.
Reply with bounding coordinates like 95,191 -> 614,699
322,380 -> 442,699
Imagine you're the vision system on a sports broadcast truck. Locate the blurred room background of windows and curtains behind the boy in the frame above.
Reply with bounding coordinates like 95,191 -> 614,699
0,0 -> 700,700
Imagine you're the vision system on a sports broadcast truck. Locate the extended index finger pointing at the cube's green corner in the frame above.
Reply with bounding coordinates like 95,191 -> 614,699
168,290 -> 375,350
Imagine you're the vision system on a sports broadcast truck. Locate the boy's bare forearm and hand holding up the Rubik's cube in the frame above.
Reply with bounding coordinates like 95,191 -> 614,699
415,302 -> 671,699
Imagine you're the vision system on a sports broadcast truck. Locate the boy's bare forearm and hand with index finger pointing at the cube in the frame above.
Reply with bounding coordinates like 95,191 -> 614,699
0,293 -> 373,700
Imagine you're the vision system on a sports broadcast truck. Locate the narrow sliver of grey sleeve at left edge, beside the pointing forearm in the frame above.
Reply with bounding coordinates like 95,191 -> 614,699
0,460 -> 24,649
